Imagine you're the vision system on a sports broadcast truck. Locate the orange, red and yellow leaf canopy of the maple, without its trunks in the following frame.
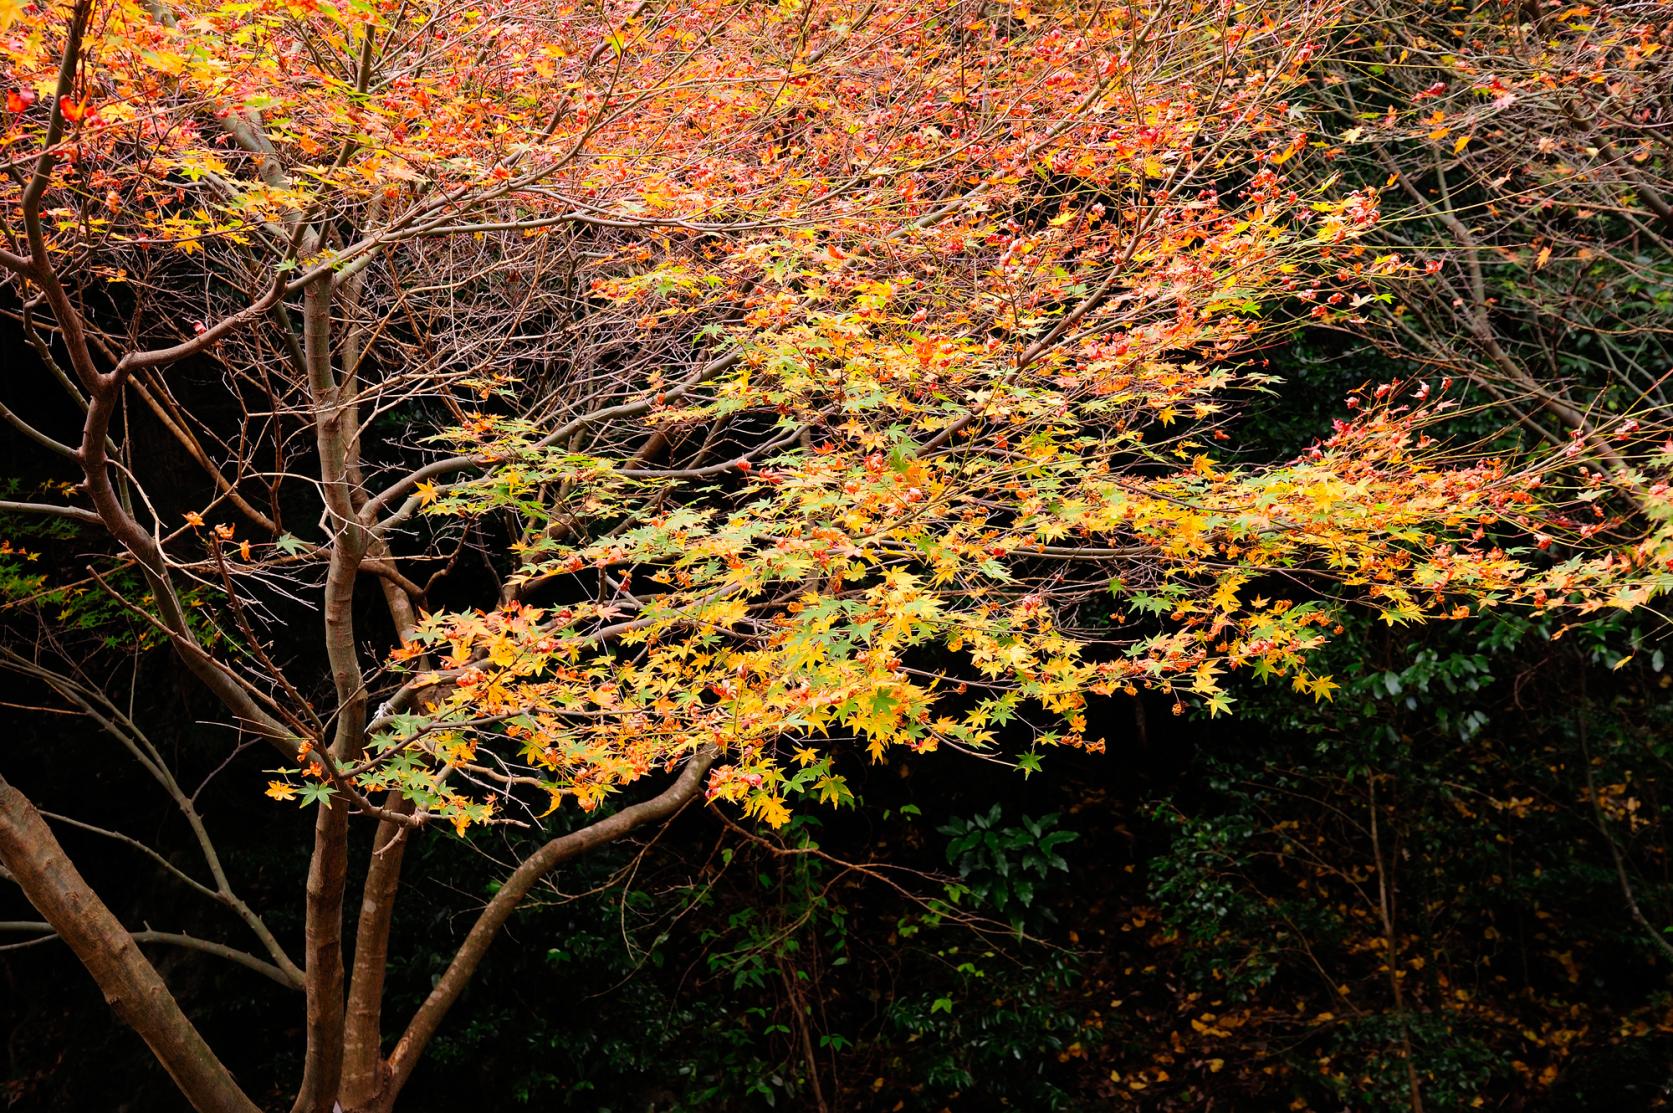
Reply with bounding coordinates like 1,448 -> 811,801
52,0 -> 1666,827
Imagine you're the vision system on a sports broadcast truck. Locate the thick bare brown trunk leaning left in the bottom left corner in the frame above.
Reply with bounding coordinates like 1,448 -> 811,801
0,778 -> 258,1113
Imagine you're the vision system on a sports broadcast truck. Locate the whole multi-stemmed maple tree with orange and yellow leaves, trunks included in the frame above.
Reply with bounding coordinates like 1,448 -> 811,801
0,0 -> 1670,1110
